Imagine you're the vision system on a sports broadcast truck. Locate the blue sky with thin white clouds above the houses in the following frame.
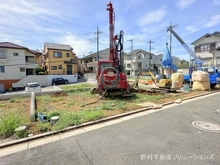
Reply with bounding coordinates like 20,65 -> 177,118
0,0 -> 220,60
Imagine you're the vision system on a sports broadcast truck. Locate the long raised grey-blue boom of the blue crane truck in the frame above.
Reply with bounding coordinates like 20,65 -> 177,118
167,27 -> 203,69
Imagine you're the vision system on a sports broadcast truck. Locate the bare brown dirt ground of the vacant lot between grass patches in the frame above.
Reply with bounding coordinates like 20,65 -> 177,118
0,88 -> 213,140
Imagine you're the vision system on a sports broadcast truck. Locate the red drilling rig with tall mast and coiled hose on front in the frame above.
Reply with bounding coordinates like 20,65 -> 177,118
92,2 -> 130,96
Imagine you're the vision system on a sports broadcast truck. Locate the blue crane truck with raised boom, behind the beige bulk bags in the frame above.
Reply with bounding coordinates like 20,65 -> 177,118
167,27 -> 220,87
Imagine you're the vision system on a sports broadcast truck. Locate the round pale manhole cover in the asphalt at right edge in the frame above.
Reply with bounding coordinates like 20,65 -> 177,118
192,121 -> 220,133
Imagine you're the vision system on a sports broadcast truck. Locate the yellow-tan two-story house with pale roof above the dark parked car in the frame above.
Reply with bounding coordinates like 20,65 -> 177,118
42,42 -> 78,75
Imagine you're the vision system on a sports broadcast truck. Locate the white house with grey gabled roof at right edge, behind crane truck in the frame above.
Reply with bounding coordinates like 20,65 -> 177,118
192,31 -> 220,66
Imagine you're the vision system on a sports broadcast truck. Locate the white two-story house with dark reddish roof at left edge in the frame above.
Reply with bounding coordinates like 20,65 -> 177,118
0,42 -> 41,91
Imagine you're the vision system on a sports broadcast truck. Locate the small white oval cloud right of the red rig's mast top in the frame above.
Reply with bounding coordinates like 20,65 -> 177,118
138,7 -> 167,26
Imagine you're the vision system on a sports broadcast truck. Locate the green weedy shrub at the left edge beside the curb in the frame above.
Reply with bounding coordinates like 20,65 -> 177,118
0,113 -> 24,137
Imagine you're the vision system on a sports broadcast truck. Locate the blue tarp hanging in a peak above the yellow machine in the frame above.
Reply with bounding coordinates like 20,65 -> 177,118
161,45 -> 177,71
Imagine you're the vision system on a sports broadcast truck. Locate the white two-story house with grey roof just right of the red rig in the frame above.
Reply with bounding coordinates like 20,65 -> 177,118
124,49 -> 162,76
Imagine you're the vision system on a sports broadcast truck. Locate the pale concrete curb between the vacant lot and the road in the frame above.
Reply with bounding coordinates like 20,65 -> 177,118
0,90 -> 220,149
